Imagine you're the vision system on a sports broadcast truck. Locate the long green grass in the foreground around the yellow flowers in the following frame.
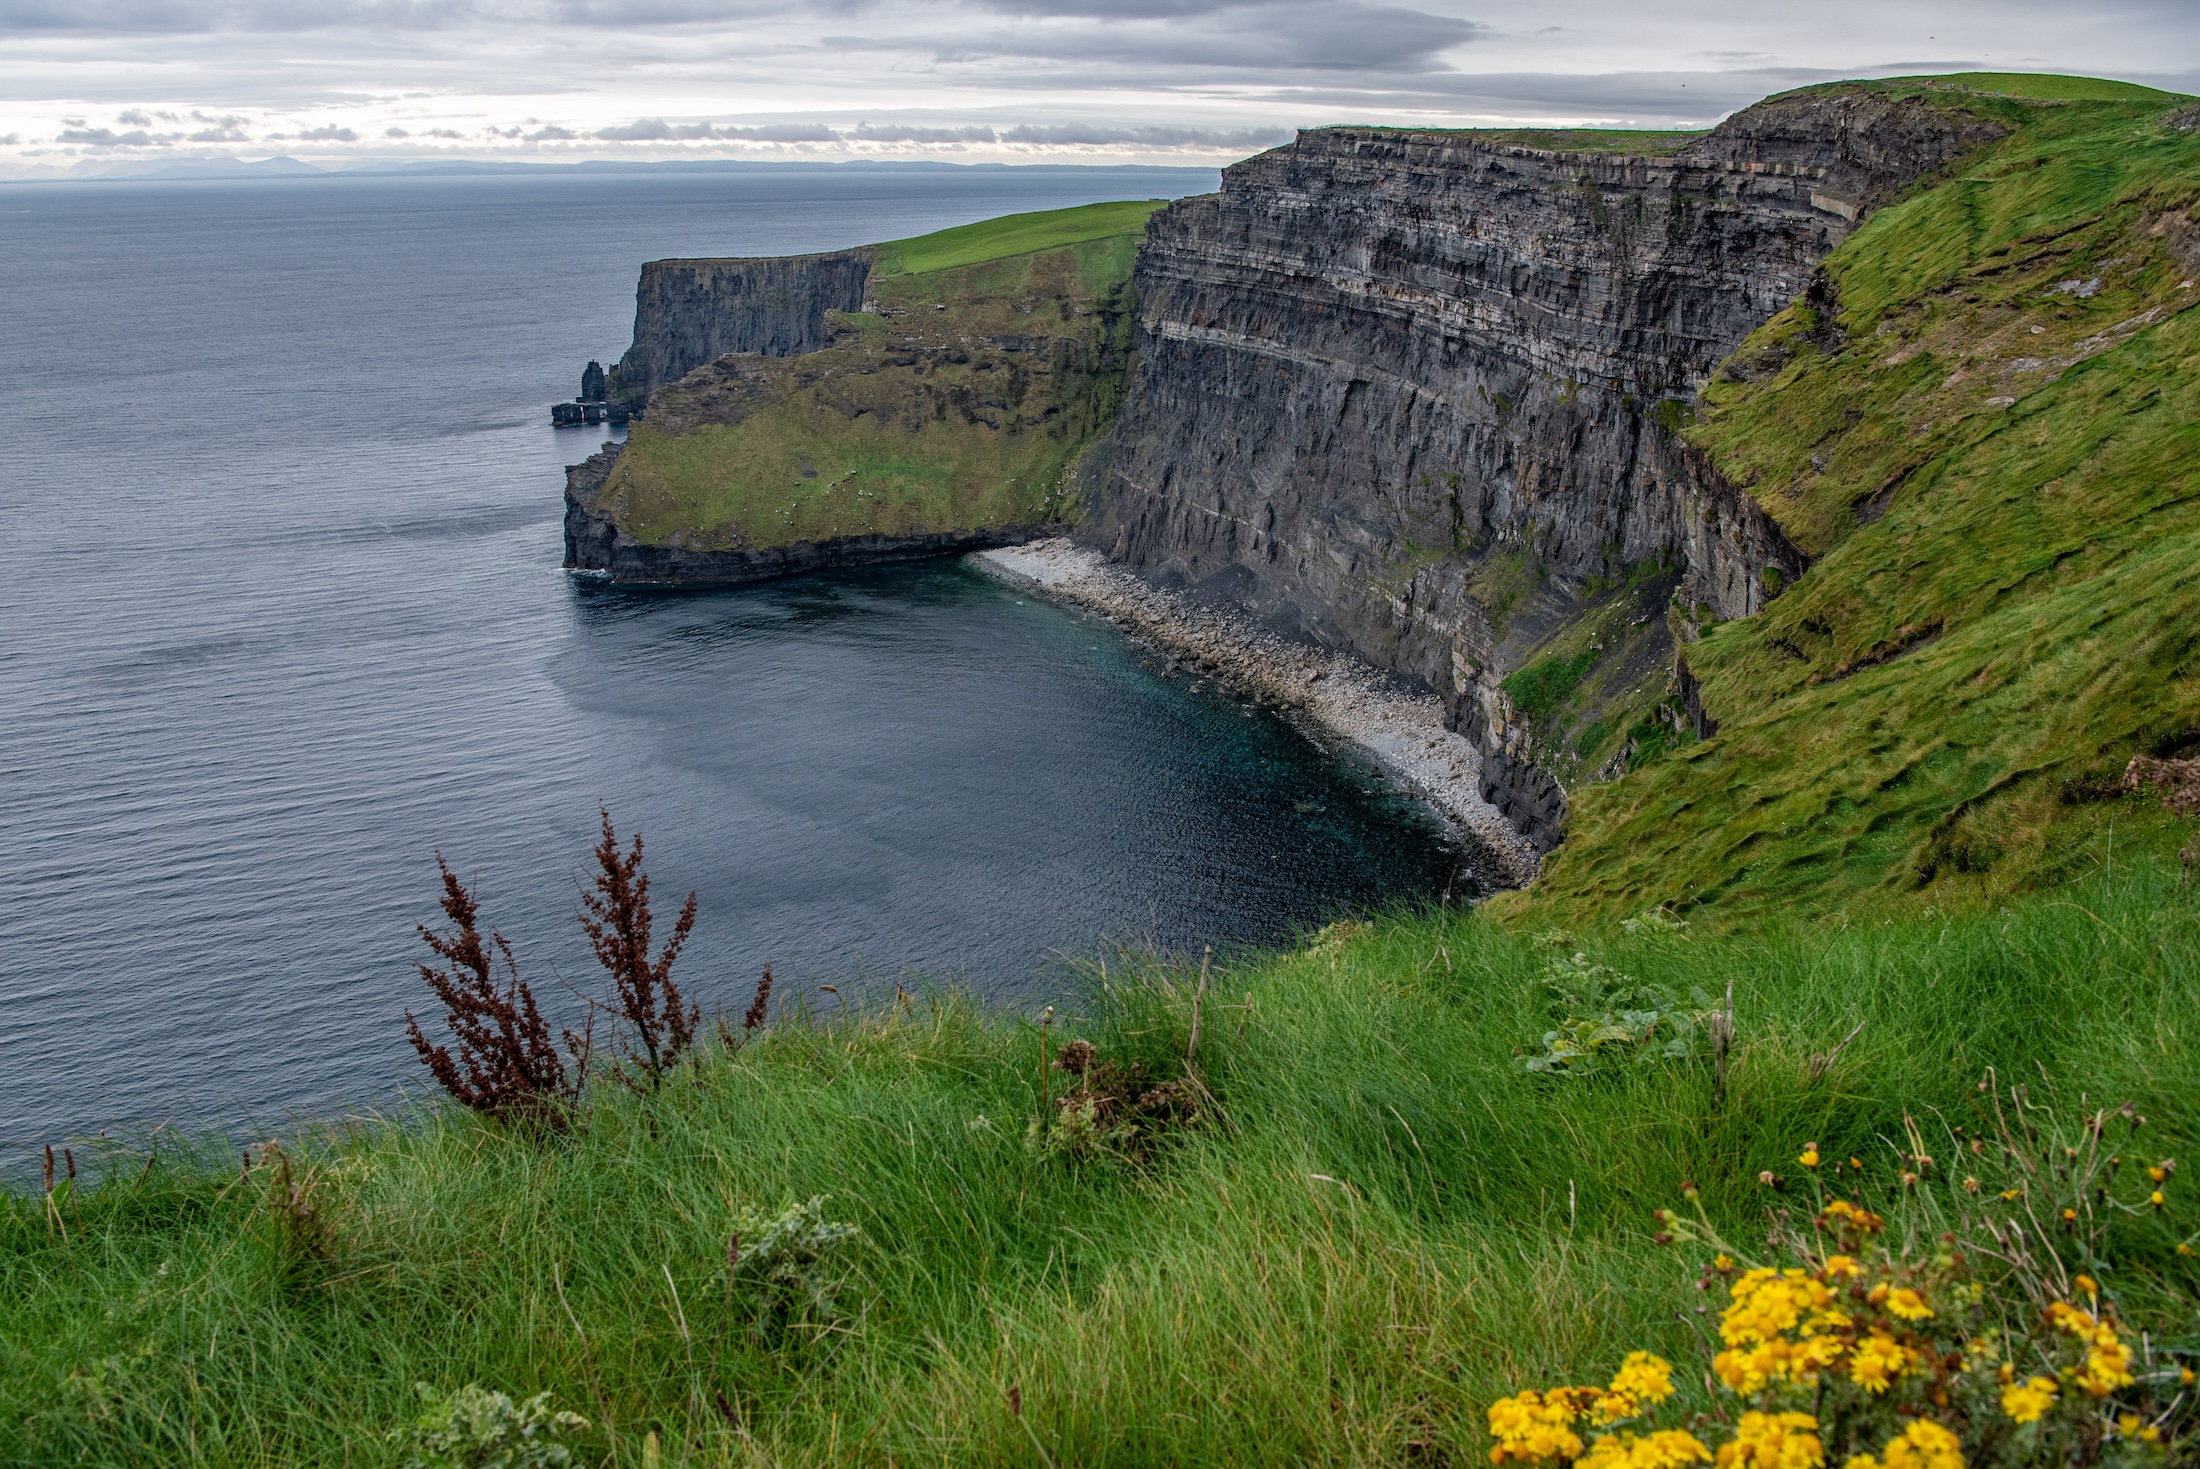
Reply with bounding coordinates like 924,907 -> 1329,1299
0,864 -> 2200,1465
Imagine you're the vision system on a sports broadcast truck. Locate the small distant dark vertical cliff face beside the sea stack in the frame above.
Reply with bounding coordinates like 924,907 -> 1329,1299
614,251 -> 871,407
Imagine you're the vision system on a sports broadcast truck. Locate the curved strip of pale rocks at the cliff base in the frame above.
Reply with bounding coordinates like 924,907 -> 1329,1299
970,539 -> 1538,886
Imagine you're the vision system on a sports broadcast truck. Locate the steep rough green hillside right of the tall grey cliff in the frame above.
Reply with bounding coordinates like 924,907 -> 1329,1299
1507,77 -> 2200,917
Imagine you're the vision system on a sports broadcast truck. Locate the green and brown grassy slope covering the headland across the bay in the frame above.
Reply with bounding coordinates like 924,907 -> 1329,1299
605,200 -> 1159,548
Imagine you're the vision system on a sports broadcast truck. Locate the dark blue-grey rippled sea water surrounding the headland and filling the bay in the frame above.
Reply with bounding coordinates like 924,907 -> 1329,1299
0,169 -> 1450,1172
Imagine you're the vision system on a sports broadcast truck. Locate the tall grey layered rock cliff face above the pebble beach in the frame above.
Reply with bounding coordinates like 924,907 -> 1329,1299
1089,95 -> 1993,842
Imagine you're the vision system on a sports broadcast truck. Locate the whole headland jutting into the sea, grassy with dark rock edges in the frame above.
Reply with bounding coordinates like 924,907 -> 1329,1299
565,202 -> 1157,583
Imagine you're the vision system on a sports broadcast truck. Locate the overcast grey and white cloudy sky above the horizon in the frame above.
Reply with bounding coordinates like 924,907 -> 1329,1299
0,0 -> 2200,176
